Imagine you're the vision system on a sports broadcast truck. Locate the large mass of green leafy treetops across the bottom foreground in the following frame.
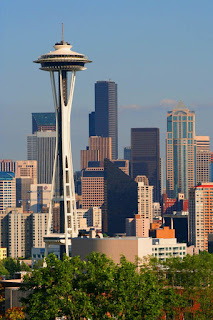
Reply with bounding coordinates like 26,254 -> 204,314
20,253 -> 213,320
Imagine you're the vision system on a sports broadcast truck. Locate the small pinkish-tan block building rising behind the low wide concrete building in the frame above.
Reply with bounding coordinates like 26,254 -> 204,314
126,214 -> 150,237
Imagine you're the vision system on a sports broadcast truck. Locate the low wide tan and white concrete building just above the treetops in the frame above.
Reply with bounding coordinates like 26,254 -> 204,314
72,237 -> 186,263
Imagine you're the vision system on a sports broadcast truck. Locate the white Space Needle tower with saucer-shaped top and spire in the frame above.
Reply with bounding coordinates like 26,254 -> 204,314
34,24 -> 92,259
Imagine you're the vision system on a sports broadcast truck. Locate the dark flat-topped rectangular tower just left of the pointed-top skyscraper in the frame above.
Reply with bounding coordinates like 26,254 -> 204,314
131,128 -> 160,202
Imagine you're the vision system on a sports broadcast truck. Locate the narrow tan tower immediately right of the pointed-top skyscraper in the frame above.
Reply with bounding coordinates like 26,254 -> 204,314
195,136 -> 211,183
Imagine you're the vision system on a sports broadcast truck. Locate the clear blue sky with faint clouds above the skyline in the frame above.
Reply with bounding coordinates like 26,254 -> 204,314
0,0 -> 213,170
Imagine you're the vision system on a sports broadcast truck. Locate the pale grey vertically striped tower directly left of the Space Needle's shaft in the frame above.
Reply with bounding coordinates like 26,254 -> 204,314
27,131 -> 56,184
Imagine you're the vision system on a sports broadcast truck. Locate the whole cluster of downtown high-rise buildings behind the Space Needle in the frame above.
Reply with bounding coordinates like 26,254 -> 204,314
0,80 -> 213,263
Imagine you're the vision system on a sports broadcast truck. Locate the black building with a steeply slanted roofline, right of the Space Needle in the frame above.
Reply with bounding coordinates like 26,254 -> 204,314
102,159 -> 138,236
